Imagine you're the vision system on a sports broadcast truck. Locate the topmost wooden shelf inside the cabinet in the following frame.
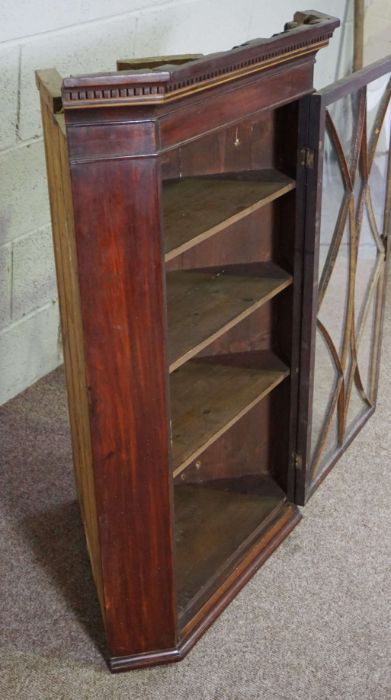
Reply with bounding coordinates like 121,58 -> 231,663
163,170 -> 295,261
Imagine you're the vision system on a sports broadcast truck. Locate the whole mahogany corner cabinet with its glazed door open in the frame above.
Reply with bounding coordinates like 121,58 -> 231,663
37,12 -> 391,671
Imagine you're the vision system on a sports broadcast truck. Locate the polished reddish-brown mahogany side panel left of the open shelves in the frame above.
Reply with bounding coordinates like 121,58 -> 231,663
69,148 -> 176,656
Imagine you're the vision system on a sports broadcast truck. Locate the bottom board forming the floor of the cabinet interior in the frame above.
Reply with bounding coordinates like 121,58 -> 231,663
174,475 -> 287,621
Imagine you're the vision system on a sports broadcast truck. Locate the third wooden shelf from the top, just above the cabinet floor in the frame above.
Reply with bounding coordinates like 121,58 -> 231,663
170,351 -> 289,477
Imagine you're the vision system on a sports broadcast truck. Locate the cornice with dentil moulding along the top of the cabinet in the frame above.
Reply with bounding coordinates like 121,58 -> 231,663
62,10 -> 340,110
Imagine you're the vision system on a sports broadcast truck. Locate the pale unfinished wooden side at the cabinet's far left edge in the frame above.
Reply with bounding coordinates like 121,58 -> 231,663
41,100 -> 103,607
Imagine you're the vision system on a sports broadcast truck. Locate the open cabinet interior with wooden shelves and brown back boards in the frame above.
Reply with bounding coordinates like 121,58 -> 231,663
161,103 -> 297,626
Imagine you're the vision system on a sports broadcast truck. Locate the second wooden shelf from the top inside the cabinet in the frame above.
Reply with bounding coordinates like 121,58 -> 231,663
167,263 -> 292,372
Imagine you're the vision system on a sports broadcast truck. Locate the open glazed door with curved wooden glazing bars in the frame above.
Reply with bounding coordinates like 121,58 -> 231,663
295,57 -> 391,503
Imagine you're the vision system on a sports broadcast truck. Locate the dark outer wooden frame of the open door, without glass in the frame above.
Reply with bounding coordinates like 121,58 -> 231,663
294,55 -> 391,505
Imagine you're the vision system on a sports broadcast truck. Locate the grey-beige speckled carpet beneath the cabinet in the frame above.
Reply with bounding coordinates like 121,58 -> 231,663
0,289 -> 391,700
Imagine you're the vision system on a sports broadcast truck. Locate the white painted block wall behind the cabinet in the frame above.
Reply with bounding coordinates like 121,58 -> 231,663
0,0 -> 391,404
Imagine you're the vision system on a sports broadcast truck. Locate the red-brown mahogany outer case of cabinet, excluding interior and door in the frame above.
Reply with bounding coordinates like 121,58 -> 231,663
38,12 -> 339,671
